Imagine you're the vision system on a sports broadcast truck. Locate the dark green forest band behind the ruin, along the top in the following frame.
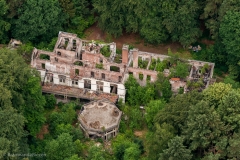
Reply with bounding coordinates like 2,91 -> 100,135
0,0 -> 240,81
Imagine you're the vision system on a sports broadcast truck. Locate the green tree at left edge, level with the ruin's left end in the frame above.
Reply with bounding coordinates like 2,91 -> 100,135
0,48 -> 32,110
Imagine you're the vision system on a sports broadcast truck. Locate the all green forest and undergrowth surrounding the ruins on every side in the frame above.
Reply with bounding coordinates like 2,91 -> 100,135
0,0 -> 240,160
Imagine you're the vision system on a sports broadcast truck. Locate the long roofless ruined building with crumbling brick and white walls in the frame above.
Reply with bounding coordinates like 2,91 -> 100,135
31,32 -> 214,102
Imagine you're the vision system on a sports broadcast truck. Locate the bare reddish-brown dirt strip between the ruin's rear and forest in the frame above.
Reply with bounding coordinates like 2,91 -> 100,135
85,24 -> 182,54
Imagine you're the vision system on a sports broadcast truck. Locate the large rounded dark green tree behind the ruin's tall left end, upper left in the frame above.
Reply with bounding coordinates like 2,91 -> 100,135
13,0 -> 64,43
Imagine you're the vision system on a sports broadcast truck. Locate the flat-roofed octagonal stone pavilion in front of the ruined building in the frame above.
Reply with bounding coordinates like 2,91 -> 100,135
78,99 -> 122,140
